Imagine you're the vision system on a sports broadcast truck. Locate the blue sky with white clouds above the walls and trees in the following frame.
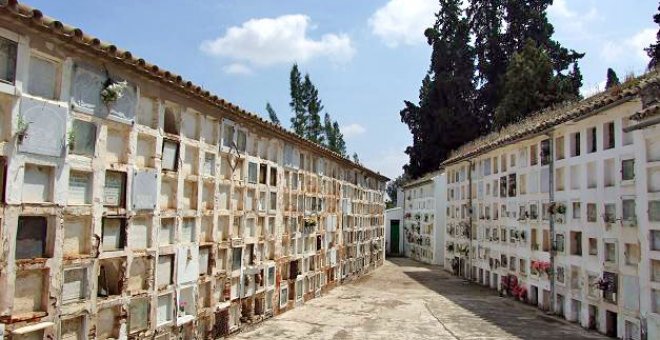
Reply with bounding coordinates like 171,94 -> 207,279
26,0 -> 658,178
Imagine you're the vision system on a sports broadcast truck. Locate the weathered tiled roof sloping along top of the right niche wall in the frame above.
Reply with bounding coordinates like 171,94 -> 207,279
440,70 -> 660,167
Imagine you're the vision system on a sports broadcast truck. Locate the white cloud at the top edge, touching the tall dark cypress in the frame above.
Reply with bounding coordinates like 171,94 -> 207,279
369,0 -> 438,48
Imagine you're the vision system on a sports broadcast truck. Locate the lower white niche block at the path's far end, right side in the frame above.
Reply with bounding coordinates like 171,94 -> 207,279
399,172 -> 447,265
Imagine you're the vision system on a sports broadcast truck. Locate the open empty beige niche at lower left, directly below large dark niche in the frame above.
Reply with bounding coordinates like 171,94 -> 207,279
12,270 -> 49,316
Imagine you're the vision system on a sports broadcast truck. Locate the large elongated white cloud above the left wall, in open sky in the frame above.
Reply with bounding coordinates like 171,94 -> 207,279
200,14 -> 355,67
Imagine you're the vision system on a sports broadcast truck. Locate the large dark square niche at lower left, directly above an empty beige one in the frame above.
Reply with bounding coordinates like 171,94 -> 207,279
16,216 -> 54,260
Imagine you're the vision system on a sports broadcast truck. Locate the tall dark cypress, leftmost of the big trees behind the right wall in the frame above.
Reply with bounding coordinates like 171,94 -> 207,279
400,0 -> 480,178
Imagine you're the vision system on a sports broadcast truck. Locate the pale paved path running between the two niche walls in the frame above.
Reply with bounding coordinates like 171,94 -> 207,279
234,258 -> 605,340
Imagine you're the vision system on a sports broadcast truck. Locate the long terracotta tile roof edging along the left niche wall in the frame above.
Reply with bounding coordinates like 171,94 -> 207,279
0,0 -> 389,181
